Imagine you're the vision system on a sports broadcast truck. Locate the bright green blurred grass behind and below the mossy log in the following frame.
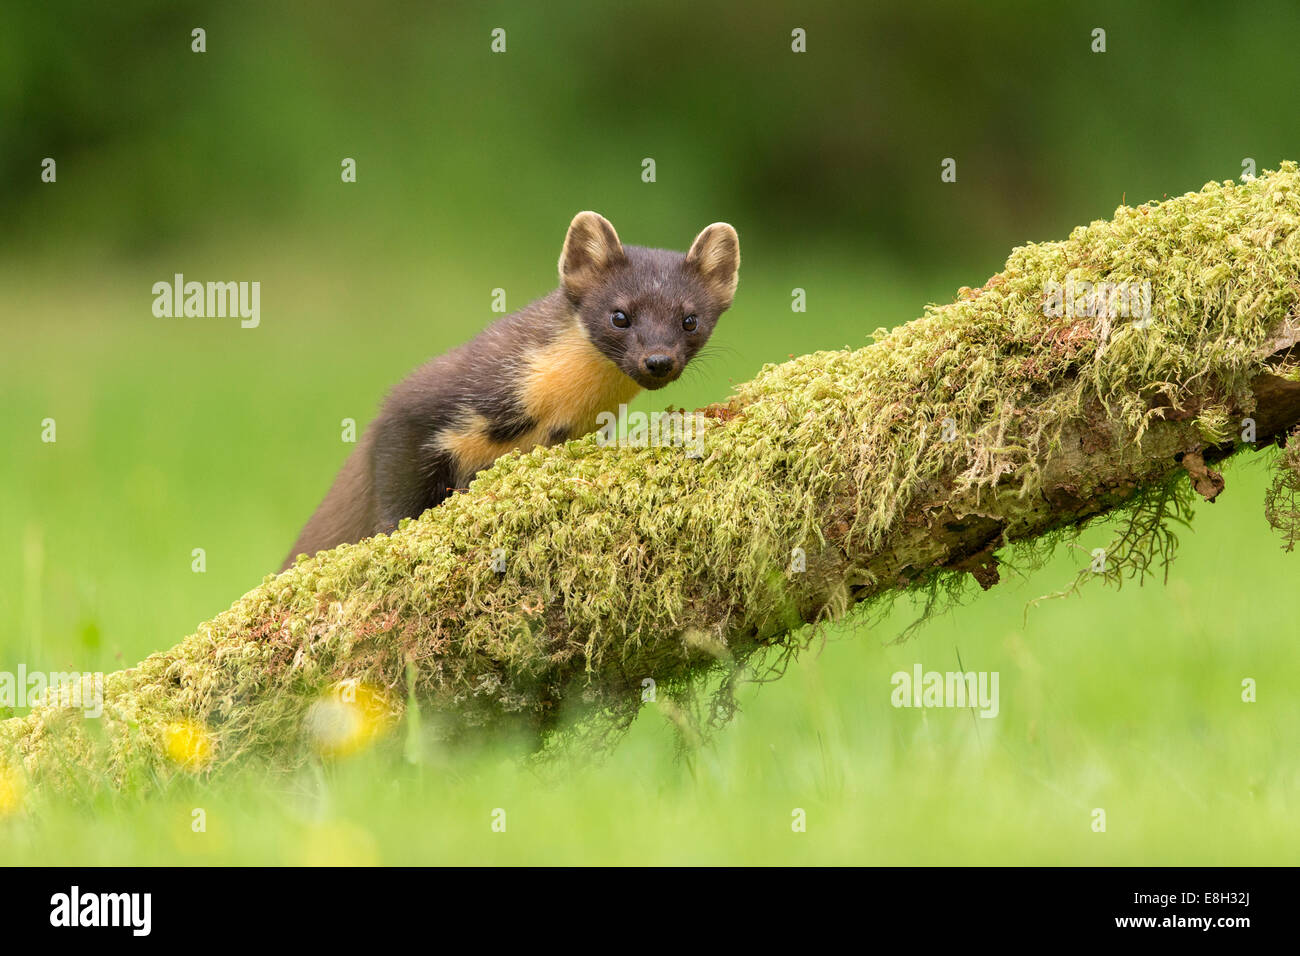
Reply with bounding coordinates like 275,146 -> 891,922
0,237 -> 1300,865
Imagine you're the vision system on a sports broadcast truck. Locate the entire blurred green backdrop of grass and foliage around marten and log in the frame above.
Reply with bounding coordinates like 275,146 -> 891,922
0,0 -> 1300,864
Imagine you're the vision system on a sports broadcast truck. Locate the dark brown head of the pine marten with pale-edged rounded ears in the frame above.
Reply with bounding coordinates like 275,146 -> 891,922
560,212 -> 740,389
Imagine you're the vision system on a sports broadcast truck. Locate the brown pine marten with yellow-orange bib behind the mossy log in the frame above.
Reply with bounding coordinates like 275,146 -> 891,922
281,212 -> 740,570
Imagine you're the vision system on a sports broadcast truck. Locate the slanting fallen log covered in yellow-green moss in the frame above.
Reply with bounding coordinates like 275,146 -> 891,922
0,163 -> 1300,791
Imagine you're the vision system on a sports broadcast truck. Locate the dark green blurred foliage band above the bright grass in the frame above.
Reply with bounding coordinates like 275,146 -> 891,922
0,0 -> 1300,269
